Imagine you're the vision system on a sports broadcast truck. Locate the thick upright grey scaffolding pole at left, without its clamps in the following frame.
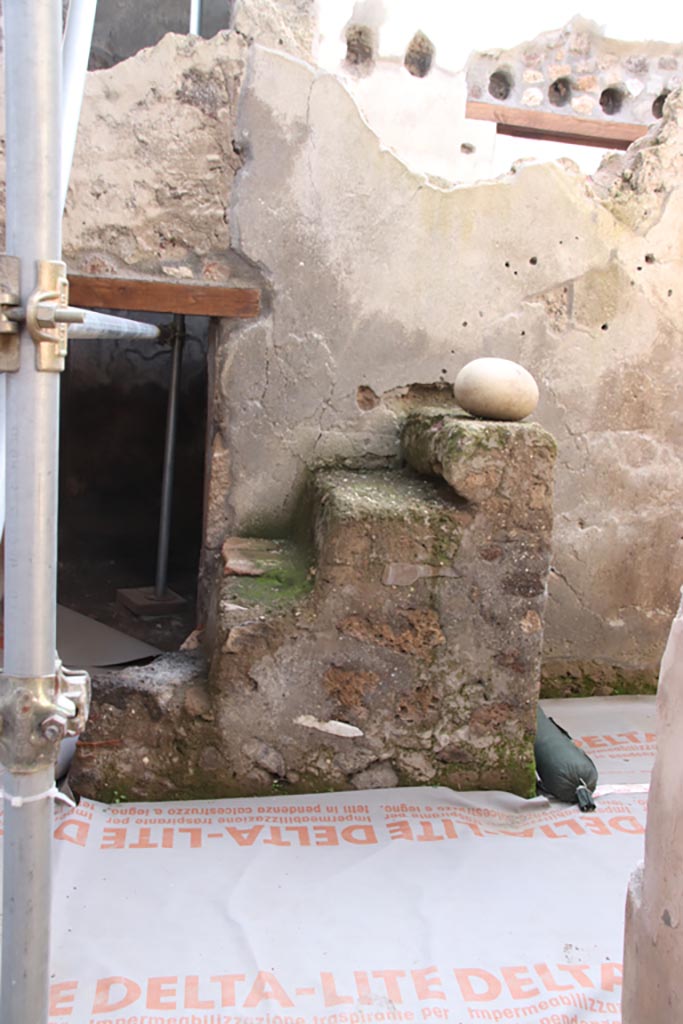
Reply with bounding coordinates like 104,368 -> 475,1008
0,0 -> 61,1024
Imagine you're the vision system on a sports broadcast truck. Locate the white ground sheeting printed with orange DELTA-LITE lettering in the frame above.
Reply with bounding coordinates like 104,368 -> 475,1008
5,698 -> 653,1024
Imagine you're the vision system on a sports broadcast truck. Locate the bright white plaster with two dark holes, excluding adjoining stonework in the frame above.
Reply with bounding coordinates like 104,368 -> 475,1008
313,6 -> 603,183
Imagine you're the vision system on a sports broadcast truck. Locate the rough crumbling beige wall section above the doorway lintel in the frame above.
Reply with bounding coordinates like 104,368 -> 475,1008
63,33 -> 246,280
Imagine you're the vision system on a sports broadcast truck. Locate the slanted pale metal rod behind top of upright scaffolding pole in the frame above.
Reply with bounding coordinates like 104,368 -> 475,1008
60,0 -> 97,210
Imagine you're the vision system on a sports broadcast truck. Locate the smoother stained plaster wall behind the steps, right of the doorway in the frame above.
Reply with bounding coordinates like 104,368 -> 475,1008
214,48 -> 683,688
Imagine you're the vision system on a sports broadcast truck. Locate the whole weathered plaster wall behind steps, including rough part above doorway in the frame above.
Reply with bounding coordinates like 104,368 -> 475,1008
54,33 -> 683,675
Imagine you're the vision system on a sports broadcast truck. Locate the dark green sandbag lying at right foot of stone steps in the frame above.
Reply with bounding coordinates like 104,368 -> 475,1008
533,706 -> 598,811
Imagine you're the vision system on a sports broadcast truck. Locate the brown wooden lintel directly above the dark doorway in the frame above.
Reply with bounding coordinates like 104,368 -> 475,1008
69,273 -> 261,319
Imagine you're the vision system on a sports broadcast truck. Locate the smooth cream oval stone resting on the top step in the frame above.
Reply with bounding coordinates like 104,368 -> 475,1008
453,356 -> 539,420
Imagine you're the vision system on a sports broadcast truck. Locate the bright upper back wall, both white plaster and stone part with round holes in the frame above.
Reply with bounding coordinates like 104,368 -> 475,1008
314,7 -> 681,183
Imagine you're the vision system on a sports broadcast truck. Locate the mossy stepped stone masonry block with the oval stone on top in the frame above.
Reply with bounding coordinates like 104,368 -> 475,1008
72,409 -> 555,797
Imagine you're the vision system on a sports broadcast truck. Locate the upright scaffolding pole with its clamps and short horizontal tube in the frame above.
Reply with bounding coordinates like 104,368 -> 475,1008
0,0 -> 164,1024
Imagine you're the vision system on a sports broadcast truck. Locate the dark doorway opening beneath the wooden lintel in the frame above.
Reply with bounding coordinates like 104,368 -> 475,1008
58,310 -> 208,650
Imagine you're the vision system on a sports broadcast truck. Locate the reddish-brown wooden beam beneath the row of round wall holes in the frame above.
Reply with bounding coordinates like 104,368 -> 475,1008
465,99 -> 648,150
